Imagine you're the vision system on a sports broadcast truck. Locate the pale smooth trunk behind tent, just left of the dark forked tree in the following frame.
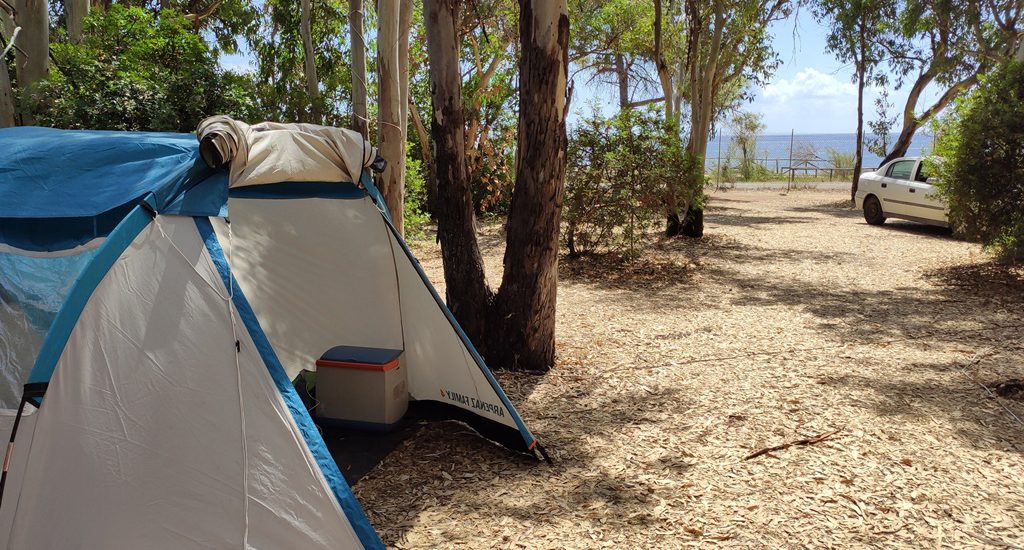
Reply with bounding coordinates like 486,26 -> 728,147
377,0 -> 409,234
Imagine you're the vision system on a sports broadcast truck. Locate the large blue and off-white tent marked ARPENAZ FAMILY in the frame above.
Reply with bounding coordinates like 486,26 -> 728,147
0,125 -> 537,549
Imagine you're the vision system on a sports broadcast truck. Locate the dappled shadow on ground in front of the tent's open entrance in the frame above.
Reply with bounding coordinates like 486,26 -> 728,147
356,375 -> 694,545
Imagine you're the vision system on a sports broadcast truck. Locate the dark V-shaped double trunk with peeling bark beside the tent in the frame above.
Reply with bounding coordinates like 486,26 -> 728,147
424,0 -> 569,370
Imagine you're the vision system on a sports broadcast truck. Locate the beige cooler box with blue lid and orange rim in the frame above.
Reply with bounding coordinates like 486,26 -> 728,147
316,345 -> 409,431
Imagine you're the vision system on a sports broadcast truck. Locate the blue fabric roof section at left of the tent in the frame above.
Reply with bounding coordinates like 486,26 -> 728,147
0,127 -> 227,219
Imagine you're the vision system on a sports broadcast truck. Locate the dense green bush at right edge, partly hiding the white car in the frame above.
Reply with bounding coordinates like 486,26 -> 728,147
934,61 -> 1024,261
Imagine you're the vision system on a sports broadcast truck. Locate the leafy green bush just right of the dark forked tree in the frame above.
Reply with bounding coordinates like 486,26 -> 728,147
563,110 -> 707,257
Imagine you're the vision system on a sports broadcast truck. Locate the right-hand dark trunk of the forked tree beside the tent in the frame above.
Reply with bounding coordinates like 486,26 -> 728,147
487,0 -> 569,371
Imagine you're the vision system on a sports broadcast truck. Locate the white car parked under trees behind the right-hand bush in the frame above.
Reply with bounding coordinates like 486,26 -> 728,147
855,157 -> 949,227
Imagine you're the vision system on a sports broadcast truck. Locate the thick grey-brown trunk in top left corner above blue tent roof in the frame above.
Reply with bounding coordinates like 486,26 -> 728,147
14,0 -> 50,124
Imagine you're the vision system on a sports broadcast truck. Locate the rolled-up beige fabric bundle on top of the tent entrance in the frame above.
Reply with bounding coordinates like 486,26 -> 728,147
198,115 -> 377,187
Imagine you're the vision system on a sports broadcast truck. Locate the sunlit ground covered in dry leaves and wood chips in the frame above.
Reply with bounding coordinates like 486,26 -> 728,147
355,191 -> 1024,548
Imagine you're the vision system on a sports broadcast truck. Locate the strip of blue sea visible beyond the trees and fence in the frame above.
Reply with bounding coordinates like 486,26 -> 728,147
706,133 -> 933,169
